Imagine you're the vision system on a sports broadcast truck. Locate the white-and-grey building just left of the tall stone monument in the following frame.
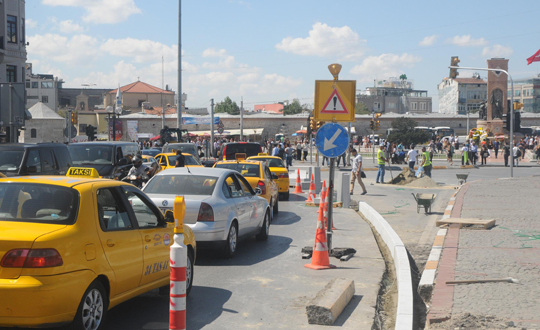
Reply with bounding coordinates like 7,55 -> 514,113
437,73 -> 487,115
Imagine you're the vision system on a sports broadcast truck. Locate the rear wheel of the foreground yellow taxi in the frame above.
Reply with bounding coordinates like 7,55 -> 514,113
68,280 -> 109,330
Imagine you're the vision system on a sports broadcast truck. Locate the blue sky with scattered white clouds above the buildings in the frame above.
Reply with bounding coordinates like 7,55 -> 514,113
26,0 -> 540,112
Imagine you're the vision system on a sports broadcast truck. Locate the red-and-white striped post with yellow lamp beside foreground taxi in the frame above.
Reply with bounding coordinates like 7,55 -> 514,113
169,196 -> 187,330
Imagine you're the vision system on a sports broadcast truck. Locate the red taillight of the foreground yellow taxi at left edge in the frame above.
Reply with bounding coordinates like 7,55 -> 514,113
0,249 -> 64,268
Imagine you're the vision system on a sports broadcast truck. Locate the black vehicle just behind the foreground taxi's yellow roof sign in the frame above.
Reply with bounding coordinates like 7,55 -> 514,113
68,142 -> 141,179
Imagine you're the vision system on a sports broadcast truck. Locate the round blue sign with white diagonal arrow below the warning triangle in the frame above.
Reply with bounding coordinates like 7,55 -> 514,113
315,123 -> 349,158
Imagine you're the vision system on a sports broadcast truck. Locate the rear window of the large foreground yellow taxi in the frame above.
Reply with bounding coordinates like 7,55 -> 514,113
0,182 -> 79,224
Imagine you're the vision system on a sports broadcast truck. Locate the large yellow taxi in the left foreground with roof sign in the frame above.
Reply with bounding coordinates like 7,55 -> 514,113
0,167 -> 196,329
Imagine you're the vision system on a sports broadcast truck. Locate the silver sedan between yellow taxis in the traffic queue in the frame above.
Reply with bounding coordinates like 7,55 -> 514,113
143,167 -> 270,258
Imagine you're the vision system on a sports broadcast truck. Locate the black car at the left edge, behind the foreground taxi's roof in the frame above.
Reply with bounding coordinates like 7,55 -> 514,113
0,143 -> 73,176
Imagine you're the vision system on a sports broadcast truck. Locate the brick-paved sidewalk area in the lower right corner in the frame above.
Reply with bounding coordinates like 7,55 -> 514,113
428,177 -> 540,329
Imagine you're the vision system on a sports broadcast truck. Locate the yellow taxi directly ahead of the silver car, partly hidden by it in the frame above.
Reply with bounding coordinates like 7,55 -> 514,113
214,154 -> 279,218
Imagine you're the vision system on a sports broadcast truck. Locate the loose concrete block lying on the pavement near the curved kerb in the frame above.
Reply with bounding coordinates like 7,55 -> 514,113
306,278 -> 355,325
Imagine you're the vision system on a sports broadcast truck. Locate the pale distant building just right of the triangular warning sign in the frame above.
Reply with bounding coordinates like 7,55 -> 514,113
356,78 -> 432,114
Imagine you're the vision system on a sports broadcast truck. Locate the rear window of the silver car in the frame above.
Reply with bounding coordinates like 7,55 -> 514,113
143,174 -> 218,196
